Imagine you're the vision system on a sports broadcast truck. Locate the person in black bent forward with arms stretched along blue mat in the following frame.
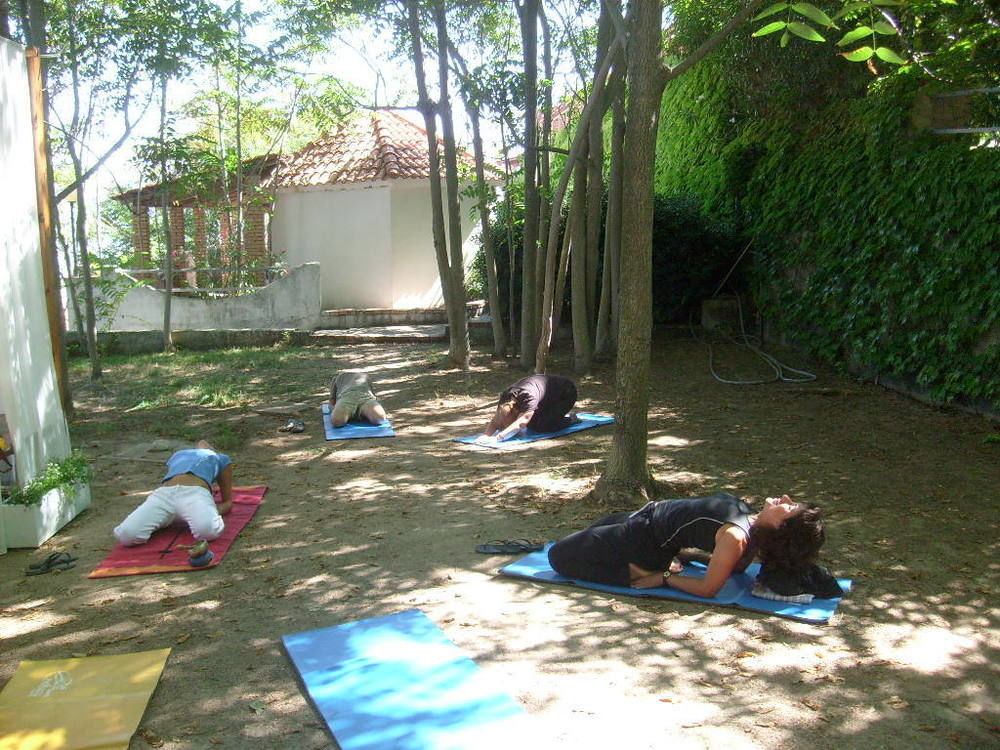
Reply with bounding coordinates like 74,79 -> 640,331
476,375 -> 579,443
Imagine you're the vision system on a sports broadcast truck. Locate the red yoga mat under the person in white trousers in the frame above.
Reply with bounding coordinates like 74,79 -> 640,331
87,486 -> 267,578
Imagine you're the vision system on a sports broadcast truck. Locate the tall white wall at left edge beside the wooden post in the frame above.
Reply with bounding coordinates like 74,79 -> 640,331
0,39 -> 70,545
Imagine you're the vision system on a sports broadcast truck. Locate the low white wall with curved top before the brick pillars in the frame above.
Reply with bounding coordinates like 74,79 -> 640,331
68,263 -> 320,331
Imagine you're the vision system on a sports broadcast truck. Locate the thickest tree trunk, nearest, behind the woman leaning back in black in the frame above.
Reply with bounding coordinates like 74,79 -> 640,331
594,2 -> 666,502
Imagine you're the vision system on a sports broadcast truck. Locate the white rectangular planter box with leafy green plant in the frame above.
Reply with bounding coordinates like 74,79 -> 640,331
0,451 -> 92,547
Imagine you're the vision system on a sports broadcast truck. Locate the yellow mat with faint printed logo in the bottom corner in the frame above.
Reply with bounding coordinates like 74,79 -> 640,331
0,648 -> 170,750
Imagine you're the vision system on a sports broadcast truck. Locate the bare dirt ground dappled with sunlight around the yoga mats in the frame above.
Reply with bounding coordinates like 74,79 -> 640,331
0,336 -> 1000,750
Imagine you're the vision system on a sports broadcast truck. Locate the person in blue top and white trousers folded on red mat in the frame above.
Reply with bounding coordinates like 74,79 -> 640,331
114,440 -> 233,545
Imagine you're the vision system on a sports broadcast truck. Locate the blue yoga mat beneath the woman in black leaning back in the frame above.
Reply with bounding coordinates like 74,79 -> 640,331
500,543 -> 851,624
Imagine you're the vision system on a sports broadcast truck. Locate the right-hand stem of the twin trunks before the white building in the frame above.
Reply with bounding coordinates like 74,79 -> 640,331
434,2 -> 469,369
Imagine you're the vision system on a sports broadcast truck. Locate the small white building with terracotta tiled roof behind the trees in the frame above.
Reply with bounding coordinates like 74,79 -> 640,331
264,110 -> 477,310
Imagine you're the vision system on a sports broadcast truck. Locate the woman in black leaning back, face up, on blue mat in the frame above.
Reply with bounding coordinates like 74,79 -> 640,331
549,493 -> 840,597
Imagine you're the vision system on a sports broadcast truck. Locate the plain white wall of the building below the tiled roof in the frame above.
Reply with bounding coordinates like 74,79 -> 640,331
271,180 -> 477,310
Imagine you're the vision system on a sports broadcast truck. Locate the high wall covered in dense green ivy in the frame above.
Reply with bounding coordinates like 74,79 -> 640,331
656,37 -> 1000,408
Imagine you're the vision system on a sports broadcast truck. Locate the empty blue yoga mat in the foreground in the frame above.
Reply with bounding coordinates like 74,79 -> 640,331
282,609 -> 530,750
